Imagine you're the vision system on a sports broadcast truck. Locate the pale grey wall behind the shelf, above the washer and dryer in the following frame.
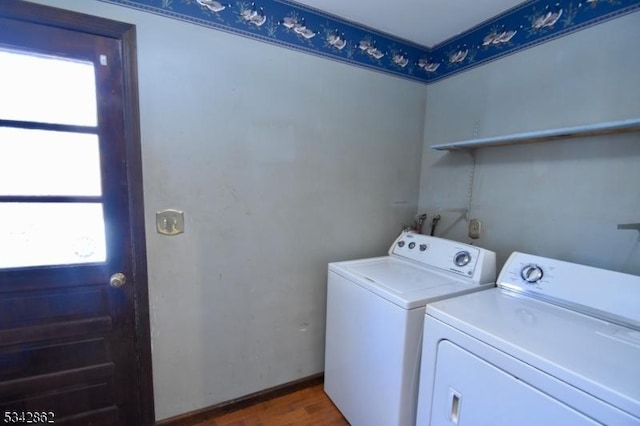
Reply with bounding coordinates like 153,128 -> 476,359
419,12 -> 640,274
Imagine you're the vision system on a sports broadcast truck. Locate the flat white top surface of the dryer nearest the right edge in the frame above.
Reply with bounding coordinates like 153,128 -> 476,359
425,289 -> 640,418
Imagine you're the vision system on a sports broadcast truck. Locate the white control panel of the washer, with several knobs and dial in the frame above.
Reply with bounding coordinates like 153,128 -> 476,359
389,232 -> 495,282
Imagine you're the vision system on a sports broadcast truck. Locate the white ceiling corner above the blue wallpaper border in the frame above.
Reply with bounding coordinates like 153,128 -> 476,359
296,0 -> 523,47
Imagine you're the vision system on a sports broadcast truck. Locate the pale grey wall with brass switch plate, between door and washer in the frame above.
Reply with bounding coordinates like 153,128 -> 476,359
27,0 -> 426,419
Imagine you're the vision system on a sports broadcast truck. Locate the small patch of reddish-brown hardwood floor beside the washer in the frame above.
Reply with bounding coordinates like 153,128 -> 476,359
195,384 -> 349,426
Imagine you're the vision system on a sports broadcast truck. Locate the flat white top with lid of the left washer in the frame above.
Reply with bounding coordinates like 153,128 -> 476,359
329,257 -> 493,309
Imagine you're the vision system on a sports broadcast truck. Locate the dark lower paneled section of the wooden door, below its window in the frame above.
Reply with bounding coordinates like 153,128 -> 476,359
0,282 -> 121,424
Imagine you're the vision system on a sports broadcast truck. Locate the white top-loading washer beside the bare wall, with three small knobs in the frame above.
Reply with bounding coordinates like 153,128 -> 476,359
324,233 -> 496,426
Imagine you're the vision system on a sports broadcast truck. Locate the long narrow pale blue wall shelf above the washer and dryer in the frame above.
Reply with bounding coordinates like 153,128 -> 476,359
431,118 -> 640,151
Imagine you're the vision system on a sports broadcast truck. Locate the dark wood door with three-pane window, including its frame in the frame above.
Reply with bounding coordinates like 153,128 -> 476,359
0,0 -> 153,425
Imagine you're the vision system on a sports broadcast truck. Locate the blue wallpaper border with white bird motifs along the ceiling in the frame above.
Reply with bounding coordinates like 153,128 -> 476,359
100,0 -> 640,83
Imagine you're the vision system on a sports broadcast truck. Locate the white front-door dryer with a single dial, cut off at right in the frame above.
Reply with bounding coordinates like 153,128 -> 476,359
416,253 -> 640,426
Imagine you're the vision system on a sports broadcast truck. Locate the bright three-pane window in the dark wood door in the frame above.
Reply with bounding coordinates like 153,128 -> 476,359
0,48 -> 106,268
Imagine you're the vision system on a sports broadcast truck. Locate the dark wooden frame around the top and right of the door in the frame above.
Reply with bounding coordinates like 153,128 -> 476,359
0,0 -> 155,425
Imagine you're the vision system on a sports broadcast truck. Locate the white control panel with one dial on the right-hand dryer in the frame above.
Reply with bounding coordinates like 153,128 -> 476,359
497,252 -> 640,326
